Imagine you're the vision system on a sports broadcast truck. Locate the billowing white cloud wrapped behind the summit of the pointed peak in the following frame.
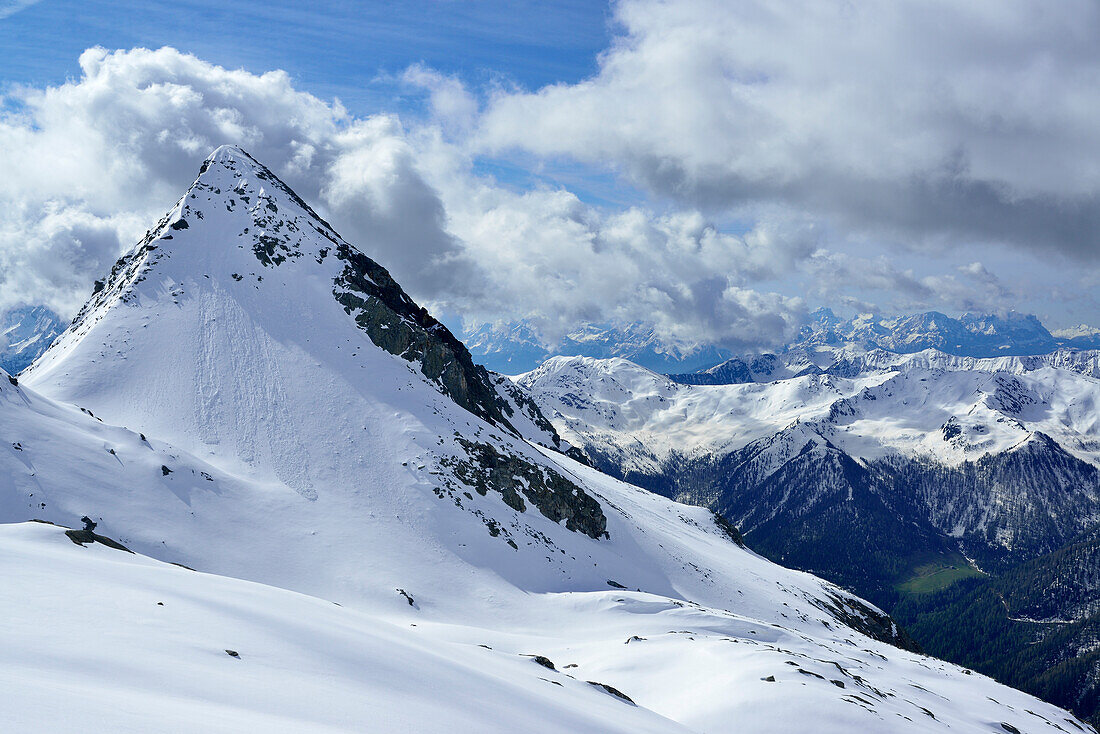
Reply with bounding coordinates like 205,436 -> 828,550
0,48 -> 462,313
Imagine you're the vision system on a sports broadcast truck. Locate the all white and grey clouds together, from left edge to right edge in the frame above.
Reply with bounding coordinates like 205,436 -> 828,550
0,0 -> 1100,349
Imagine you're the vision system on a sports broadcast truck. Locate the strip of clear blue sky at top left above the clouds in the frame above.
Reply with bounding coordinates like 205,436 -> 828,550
0,0 -> 611,114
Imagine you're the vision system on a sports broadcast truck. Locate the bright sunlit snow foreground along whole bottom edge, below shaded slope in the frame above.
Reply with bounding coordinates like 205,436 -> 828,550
12,523 -> 1088,732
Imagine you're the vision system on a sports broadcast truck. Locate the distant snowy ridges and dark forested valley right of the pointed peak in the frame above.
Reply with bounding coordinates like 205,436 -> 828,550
517,343 -> 1100,720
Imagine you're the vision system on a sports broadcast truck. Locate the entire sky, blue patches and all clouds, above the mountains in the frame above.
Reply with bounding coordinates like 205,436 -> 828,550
0,0 -> 1100,348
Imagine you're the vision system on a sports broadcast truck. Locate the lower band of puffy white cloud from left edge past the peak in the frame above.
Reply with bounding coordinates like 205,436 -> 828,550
0,48 -> 818,346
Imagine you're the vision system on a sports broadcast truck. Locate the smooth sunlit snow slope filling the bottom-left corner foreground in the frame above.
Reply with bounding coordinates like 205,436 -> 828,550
0,523 -> 686,733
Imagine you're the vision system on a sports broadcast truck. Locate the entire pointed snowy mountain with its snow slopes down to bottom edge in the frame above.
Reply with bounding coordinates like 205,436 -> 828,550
0,149 -> 1091,732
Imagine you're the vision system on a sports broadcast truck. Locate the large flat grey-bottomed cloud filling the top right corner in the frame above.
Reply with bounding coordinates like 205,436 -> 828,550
480,0 -> 1100,258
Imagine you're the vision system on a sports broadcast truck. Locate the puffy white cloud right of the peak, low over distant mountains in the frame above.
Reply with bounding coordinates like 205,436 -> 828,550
435,179 -> 815,347
